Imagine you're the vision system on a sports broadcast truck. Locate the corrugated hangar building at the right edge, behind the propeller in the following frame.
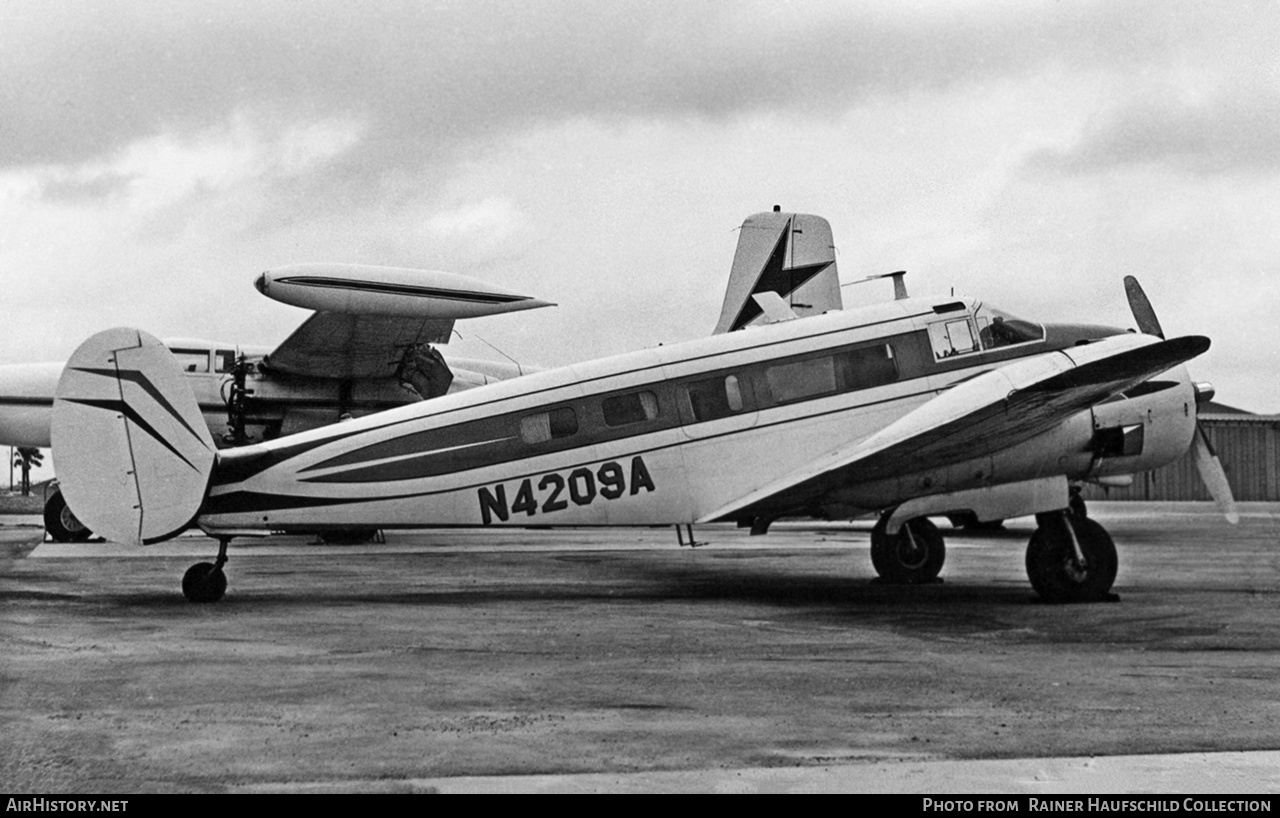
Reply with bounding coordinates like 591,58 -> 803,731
1084,403 -> 1280,501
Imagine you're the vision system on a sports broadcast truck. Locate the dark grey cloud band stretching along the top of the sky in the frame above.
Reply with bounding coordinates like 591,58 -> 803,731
0,0 -> 1233,183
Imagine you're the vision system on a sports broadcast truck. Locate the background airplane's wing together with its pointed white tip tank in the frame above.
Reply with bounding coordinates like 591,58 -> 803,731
255,264 -> 552,379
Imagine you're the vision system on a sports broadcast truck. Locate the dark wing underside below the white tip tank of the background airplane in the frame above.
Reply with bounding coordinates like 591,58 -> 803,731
257,312 -> 453,379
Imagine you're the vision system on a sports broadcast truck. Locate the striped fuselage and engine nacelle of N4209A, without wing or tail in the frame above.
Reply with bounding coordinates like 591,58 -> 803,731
198,298 -> 1194,534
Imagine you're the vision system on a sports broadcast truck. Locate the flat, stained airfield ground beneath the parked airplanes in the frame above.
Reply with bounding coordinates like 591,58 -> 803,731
0,503 -> 1280,792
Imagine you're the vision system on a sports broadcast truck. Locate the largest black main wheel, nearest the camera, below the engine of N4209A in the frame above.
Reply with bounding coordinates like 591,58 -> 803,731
1027,511 -> 1120,602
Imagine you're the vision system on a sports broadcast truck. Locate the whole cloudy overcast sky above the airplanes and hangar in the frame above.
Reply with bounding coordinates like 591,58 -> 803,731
0,0 -> 1280,412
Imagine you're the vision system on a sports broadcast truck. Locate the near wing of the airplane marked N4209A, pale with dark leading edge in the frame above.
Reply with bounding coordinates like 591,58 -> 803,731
698,335 -> 1210,522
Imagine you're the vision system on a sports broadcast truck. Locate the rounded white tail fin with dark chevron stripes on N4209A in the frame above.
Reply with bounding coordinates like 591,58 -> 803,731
50,328 -> 215,545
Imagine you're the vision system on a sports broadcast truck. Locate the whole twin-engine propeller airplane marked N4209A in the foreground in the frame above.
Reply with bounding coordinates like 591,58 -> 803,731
52,214 -> 1230,602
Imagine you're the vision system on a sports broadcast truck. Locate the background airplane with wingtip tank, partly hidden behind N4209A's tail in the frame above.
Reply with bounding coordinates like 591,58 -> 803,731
0,264 -> 550,541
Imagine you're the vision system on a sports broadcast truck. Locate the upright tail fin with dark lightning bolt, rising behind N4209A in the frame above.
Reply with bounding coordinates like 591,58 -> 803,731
713,211 -> 844,334
